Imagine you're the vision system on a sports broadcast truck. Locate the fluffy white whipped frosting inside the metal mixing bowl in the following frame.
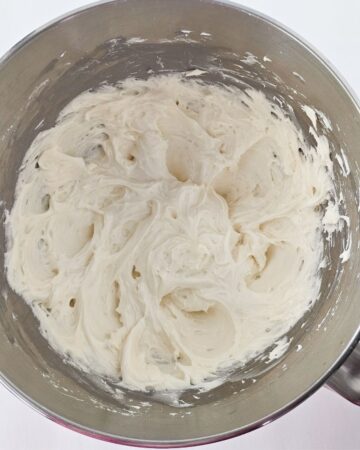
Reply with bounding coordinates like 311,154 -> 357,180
6,75 -> 337,389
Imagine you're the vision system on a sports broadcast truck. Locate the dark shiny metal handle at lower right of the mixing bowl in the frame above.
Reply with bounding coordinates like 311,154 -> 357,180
327,341 -> 360,406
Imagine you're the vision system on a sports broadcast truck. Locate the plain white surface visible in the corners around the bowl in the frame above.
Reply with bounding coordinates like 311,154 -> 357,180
0,0 -> 360,450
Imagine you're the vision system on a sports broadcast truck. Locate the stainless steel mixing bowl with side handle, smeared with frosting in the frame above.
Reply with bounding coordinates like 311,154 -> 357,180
0,0 -> 360,447
